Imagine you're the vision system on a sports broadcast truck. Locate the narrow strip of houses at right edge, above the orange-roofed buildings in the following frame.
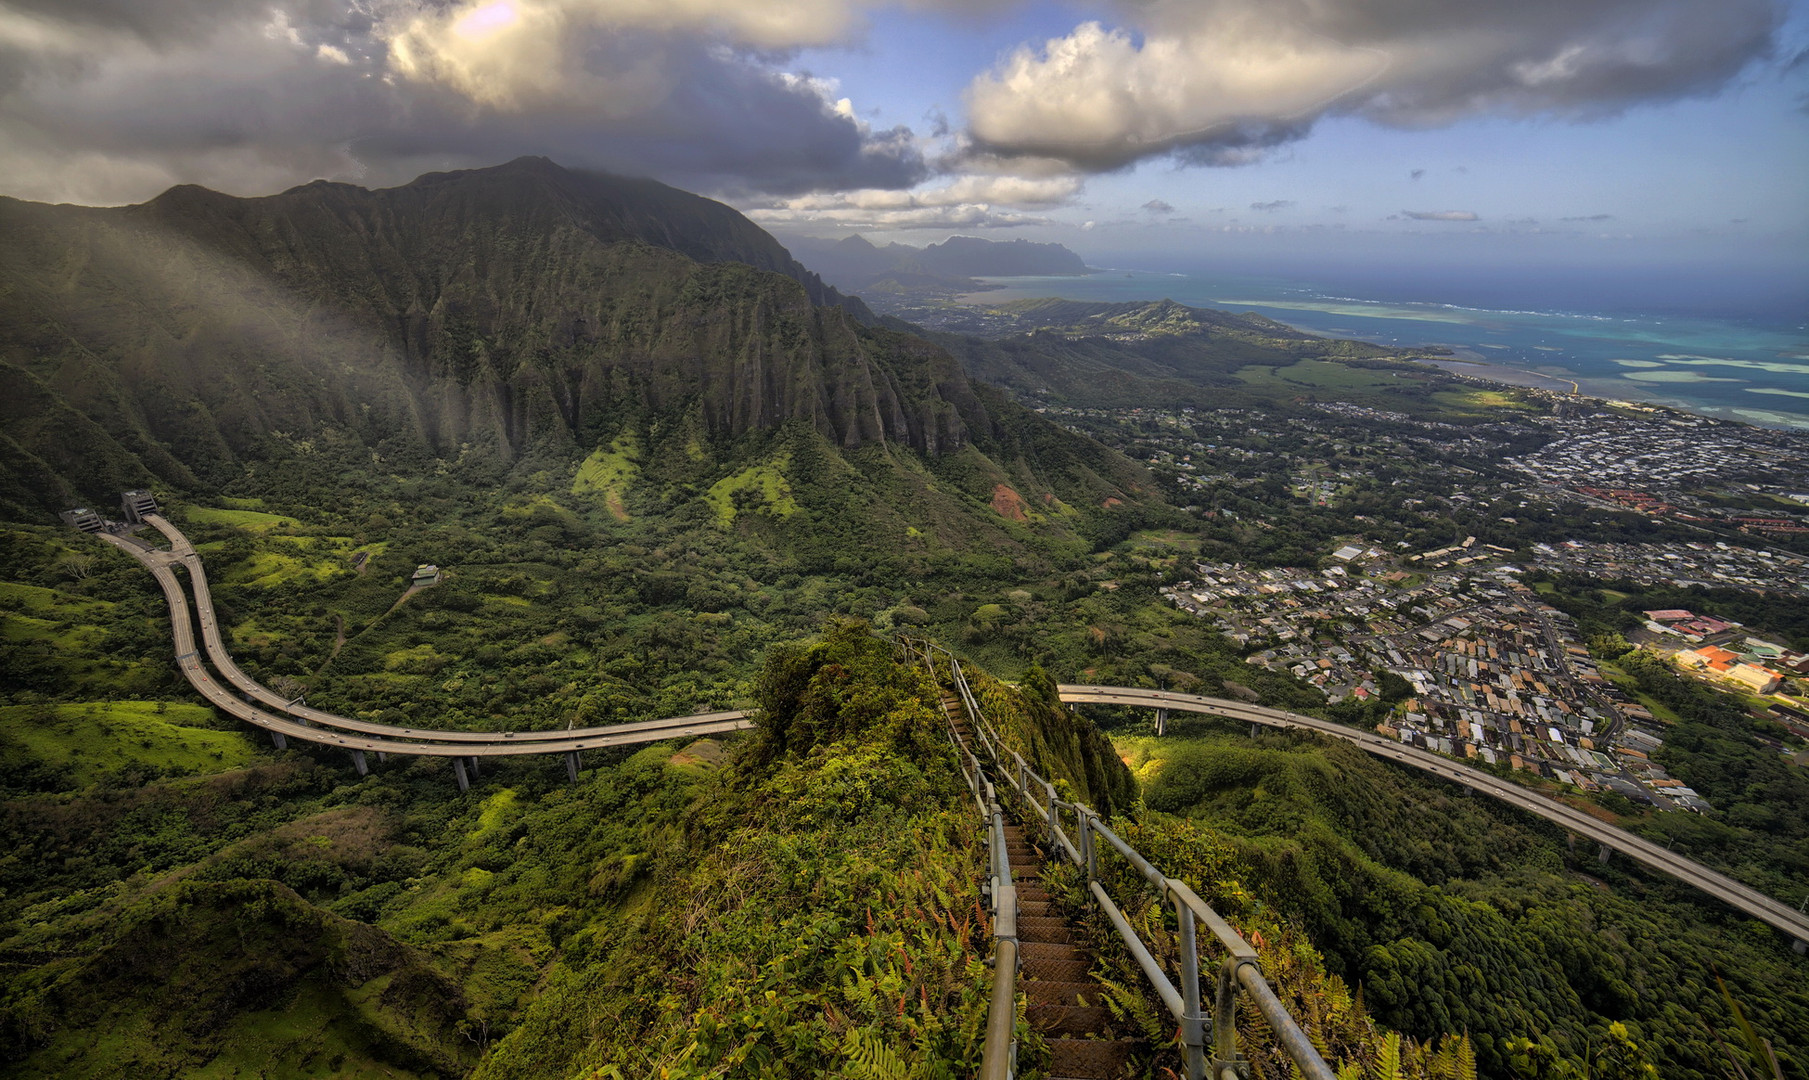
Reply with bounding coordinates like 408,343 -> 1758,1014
1532,541 -> 1809,593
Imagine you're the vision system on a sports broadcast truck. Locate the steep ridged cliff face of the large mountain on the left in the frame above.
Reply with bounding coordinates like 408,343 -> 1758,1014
0,159 -> 993,505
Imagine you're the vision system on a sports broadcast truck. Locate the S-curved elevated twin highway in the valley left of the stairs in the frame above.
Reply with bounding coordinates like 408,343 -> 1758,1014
96,528 -> 753,758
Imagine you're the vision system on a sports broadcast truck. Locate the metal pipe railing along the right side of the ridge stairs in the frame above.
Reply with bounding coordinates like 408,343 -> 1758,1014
908,639 -> 1337,1080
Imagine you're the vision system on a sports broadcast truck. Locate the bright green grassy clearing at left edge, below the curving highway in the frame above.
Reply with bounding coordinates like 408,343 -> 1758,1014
0,702 -> 259,785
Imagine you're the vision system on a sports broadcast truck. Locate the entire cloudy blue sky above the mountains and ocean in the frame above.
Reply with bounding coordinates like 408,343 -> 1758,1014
0,0 -> 1809,277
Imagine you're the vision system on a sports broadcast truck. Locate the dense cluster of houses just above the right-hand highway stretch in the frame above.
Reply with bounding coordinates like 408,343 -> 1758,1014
1163,545 -> 1708,810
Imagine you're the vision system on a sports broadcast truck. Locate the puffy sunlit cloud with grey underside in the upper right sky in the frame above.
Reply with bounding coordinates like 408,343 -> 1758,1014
966,0 -> 1780,170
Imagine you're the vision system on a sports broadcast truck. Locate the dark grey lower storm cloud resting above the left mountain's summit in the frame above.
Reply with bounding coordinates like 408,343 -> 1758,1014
0,0 -> 928,201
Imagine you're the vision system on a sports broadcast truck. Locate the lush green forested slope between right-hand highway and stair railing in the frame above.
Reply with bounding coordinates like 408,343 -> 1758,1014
1116,720 -> 1809,1076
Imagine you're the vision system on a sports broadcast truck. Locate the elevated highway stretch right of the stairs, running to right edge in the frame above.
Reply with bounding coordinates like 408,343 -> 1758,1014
1056,684 -> 1809,946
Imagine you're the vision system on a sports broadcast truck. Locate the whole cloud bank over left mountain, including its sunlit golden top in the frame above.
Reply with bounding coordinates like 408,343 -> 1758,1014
0,0 -> 932,203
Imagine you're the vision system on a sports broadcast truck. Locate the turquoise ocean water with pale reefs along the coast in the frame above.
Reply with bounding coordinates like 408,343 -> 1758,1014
973,270 -> 1809,429
